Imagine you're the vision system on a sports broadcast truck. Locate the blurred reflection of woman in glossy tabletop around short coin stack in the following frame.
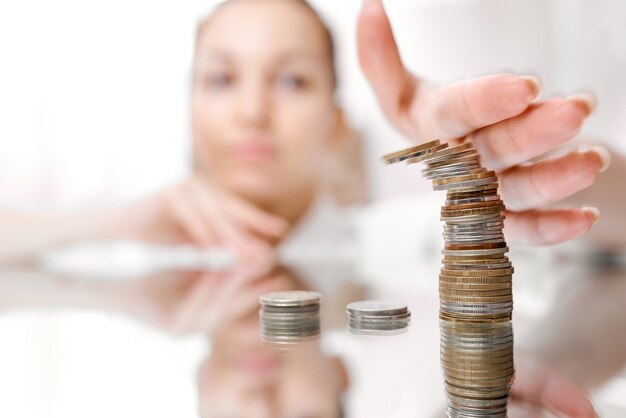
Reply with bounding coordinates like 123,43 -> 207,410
198,268 -> 348,418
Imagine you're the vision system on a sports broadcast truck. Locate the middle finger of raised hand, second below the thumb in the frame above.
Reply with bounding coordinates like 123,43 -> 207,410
470,96 -> 593,170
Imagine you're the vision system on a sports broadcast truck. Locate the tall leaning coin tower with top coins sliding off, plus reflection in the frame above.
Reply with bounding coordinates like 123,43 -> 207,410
384,141 -> 514,418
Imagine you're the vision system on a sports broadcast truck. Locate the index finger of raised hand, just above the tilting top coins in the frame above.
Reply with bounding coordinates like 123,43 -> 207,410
412,74 -> 540,141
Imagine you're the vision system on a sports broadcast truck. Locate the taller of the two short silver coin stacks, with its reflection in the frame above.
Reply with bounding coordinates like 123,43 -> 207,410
259,291 -> 321,346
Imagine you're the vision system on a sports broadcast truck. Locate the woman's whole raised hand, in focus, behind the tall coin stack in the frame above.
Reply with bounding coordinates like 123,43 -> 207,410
358,1 -> 607,244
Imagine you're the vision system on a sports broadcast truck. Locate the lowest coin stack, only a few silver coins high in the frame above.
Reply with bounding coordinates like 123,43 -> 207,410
346,300 -> 411,335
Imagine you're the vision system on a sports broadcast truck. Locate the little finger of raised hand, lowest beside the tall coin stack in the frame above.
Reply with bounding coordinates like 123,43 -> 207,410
504,208 -> 600,245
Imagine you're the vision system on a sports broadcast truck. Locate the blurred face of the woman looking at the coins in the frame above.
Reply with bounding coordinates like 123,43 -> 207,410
191,0 -> 339,204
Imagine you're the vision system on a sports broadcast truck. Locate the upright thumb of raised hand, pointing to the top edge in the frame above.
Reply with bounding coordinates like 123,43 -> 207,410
357,0 -> 417,120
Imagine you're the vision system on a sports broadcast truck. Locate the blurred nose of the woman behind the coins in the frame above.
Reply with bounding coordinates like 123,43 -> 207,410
237,78 -> 271,128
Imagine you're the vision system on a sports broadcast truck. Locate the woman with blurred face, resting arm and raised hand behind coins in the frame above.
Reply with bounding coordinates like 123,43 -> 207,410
0,0 -> 607,414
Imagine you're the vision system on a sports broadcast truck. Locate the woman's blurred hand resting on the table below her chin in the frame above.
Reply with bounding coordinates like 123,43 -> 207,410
120,178 -> 287,259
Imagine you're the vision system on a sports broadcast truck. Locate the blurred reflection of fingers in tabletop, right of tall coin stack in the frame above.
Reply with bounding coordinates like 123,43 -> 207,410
512,360 -> 597,418
